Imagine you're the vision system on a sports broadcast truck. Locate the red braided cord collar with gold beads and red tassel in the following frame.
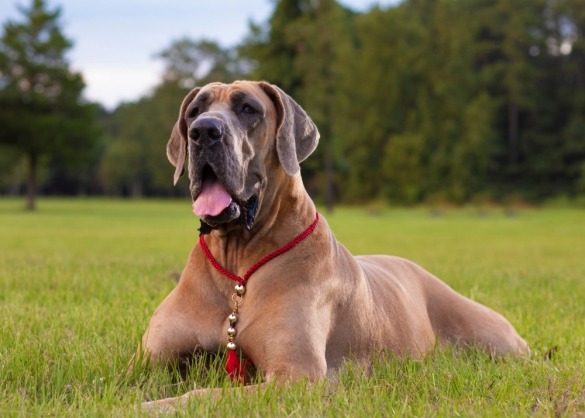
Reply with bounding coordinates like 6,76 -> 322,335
199,212 -> 319,382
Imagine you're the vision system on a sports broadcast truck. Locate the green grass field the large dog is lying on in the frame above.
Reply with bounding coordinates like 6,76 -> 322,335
0,198 -> 585,417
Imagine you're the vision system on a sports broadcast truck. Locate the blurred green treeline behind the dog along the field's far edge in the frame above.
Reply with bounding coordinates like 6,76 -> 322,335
0,0 -> 585,204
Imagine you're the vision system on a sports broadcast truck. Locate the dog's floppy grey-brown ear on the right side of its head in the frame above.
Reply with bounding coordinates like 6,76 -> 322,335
259,82 -> 319,176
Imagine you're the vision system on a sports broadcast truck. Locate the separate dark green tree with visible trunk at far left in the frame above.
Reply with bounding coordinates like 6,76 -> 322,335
0,0 -> 97,210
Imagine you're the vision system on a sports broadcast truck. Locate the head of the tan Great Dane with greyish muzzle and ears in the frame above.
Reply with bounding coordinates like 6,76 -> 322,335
167,81 -> 319,229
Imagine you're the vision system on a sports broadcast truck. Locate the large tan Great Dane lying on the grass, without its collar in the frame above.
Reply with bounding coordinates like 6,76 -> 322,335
143,82 -> 528,403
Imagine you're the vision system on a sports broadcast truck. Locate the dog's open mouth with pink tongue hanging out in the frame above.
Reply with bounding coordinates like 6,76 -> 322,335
193,165 -> 258,233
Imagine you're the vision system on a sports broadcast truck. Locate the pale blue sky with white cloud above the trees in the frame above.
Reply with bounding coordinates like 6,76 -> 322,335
0,0 -> 397,109
